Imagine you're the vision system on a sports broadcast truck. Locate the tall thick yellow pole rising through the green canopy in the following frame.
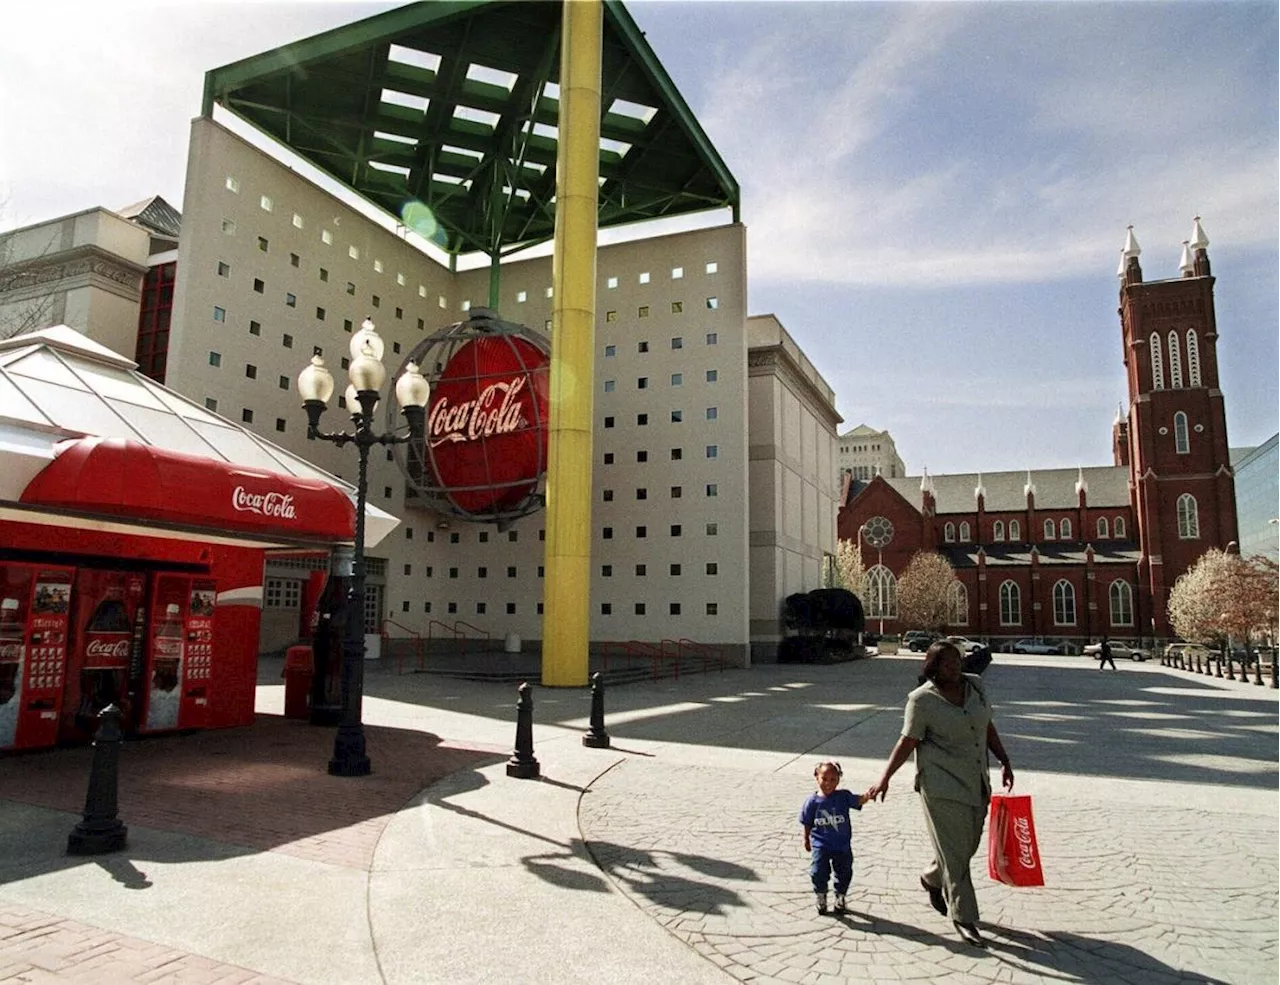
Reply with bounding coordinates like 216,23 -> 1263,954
543,0 -> 604,687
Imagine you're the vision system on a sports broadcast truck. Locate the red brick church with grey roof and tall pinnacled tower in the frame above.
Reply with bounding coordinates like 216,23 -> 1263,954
838,217 -> 1238,645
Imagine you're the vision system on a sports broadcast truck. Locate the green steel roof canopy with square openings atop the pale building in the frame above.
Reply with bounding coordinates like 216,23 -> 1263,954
202,0 -> 740,258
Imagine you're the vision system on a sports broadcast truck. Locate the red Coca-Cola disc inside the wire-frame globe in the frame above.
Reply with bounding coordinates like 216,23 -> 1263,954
426,335 -> 548,513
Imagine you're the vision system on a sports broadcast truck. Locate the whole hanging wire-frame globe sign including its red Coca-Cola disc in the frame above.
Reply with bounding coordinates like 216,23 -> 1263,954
407,310 -> 549,519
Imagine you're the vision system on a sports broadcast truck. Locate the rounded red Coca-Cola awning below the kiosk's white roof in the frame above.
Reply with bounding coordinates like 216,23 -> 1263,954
19,437 -> 356,542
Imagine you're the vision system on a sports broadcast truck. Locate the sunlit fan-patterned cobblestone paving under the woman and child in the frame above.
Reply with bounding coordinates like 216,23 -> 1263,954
580,660 -> 1280,985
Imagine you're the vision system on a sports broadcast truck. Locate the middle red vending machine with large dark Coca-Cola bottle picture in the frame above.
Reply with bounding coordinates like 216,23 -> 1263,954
59,568 -> 146,742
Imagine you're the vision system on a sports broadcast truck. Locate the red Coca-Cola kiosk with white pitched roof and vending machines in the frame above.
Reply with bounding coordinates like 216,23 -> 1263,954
0,326 -> 398,750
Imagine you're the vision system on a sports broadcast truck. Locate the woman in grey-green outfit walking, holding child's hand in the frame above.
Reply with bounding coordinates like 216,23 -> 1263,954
867,640 -> 1014,948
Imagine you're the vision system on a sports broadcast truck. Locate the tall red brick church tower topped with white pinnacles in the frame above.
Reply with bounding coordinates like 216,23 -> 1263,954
1114,216 -> 1239,637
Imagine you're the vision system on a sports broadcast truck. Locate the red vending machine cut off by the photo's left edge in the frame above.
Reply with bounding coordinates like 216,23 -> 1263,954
0,564 -> 74,750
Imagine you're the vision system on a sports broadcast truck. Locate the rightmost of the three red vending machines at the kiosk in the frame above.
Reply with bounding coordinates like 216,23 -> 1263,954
138,574 -> 216,732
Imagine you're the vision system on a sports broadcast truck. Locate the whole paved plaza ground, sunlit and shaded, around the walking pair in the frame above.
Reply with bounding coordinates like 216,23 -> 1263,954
0,644 -> 1280,985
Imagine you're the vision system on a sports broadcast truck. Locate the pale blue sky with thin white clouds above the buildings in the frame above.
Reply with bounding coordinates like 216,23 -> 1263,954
0,0 -> 1280,475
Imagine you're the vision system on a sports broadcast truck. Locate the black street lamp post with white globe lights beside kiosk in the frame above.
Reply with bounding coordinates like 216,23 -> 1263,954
298,319 -> 430,776
